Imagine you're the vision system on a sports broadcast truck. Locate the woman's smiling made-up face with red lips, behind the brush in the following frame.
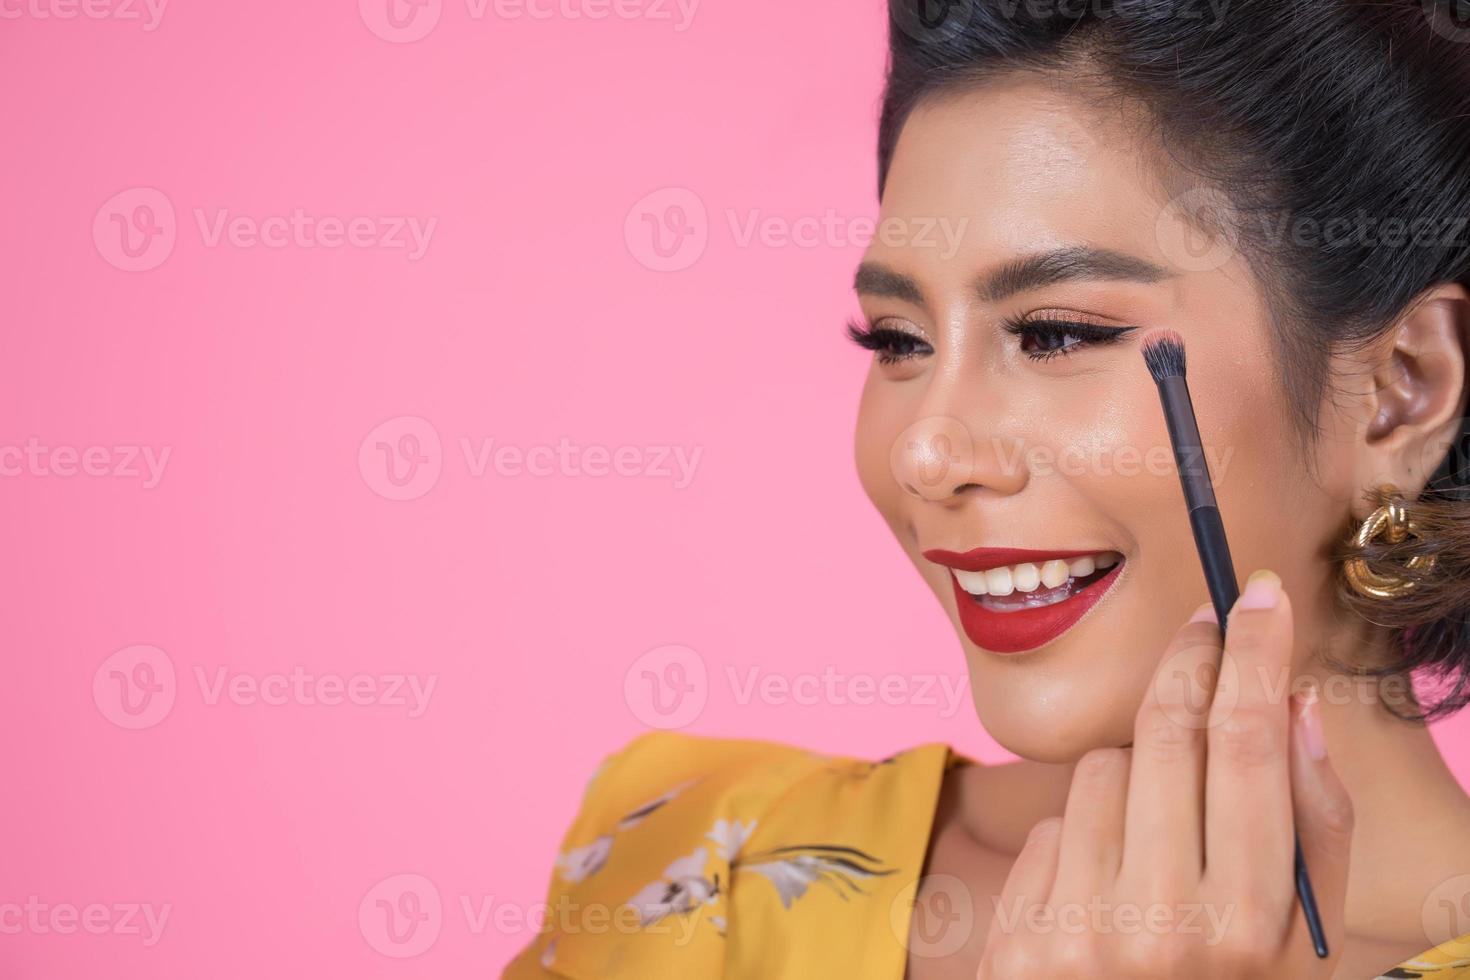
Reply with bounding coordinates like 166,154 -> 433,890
857,79 -> 1358,761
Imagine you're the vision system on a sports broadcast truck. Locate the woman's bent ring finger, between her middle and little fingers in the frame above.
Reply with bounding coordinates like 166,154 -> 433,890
1048,748 -> 1129,905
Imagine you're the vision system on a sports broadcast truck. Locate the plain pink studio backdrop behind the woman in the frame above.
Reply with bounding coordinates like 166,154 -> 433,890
0,0 -> 1470,980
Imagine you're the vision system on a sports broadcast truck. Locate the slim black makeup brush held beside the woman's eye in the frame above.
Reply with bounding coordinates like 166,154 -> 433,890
1142,331 -> 1327,959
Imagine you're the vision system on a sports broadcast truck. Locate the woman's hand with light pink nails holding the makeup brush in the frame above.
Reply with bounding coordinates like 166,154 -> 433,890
978,572 -> 1352,980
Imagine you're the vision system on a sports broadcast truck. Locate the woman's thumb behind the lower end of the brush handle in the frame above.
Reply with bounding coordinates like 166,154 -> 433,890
1289,685 -> 1352,949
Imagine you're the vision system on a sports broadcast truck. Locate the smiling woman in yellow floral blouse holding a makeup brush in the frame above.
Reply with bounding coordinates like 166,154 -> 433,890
507,0 -> 1470,980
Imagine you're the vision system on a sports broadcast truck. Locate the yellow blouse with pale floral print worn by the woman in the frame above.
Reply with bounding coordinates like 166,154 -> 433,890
503,732 -> 1470,980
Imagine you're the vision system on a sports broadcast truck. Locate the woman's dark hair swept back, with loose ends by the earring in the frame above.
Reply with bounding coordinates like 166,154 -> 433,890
878,0 -> 1470,718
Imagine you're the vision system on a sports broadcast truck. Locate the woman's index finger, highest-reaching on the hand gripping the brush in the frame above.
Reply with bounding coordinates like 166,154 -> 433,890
1204,572 -> 1294,904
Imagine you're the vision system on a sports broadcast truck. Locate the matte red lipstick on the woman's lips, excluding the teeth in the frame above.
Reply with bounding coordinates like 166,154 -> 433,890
923,548 -> 1126,654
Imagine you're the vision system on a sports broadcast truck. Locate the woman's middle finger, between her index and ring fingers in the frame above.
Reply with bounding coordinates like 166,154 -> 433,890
1119,604 -> 1220,895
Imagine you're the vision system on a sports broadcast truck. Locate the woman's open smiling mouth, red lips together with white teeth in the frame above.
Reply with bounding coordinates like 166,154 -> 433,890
923,548 -> 1125,654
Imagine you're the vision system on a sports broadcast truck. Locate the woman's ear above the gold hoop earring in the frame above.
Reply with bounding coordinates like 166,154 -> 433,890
1354,284 -> 1470,519
